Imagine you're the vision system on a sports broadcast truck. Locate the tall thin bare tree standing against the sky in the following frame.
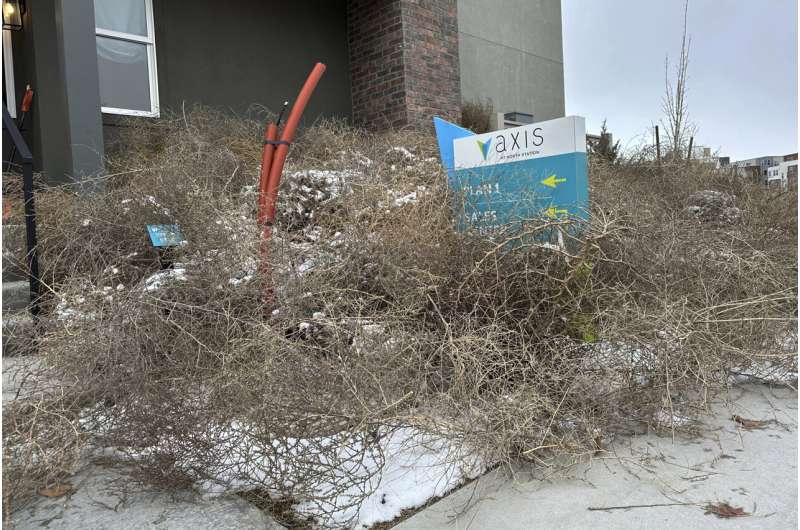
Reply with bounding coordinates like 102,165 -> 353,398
661,0 -> 696,160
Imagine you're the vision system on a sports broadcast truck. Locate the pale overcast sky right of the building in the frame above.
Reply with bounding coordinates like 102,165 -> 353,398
561,0 -> 797,160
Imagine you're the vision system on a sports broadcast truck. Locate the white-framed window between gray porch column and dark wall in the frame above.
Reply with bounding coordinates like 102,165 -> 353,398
94,0 -> 159,117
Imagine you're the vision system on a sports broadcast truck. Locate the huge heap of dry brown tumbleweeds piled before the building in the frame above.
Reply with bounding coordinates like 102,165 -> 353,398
4,109 -> 797,526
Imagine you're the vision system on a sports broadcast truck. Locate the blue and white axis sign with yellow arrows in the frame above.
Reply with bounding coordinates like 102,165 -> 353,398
434,116 -> 589,234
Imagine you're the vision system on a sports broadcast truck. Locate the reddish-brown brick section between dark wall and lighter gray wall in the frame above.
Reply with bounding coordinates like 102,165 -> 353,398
347,0 -> 461,128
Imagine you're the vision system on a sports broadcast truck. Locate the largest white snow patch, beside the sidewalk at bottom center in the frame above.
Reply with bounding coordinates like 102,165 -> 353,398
193,425 -> 484,528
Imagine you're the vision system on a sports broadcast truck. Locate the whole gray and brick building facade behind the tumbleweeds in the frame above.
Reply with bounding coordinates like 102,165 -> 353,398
3,0 -> 564,182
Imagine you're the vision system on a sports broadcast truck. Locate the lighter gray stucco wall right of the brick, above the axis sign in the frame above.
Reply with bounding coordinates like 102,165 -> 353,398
458,0 -> 564,126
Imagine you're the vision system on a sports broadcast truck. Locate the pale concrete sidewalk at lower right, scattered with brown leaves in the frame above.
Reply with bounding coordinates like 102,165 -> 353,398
395,385 -> 798,530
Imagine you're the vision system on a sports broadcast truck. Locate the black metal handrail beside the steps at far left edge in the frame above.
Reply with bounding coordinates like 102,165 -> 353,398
3,106 -> 41,318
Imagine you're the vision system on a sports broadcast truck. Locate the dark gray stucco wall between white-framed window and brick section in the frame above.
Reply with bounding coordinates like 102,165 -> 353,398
148,0 -> 351,122
